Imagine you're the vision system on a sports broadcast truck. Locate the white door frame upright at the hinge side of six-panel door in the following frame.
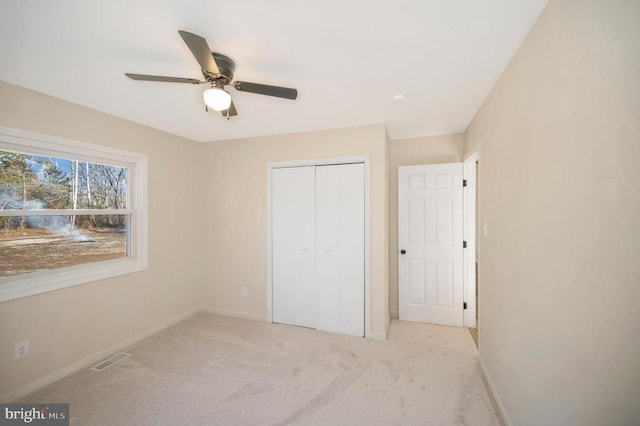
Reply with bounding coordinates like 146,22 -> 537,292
462,153 -> 479,328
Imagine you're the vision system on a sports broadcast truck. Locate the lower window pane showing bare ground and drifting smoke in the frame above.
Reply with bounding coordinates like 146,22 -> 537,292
0,215 -> 129,277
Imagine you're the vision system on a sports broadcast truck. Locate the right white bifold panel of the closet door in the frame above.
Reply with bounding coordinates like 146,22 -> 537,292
315,163 -> 364,336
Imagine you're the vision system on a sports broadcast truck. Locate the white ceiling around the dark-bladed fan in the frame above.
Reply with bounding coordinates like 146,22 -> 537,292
0,0 -> 547,142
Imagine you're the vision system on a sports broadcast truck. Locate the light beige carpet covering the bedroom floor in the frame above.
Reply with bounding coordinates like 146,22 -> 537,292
20,313 -> 501,426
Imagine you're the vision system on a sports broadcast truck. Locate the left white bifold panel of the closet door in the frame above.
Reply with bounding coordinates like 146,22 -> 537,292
271,166 -> 316,328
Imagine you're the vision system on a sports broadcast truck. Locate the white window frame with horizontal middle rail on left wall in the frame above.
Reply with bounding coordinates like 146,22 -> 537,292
0,126 -> 148,302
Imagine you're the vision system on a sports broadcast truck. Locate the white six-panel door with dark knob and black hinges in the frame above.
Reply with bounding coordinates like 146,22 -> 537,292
398,163 -> 464,326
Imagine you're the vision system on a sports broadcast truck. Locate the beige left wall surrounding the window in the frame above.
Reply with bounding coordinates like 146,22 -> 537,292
0,82 -> 203,400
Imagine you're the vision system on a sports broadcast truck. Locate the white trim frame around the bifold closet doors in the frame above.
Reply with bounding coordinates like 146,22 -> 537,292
267,156 -> 371,338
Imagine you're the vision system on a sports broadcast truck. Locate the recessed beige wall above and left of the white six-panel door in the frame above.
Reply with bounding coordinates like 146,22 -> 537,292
389,133 -> 463,318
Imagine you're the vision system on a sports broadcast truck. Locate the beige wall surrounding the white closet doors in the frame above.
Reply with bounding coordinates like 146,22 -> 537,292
200,125 -> 389,337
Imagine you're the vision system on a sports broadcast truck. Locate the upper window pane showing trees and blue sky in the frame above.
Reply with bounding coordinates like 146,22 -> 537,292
0,151 -> 128,211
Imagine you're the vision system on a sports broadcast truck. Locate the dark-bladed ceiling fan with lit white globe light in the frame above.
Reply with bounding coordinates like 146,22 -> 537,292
125,31 -> 298,119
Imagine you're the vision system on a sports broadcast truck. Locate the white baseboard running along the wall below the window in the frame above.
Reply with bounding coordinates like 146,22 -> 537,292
0,309 -> 200,401
